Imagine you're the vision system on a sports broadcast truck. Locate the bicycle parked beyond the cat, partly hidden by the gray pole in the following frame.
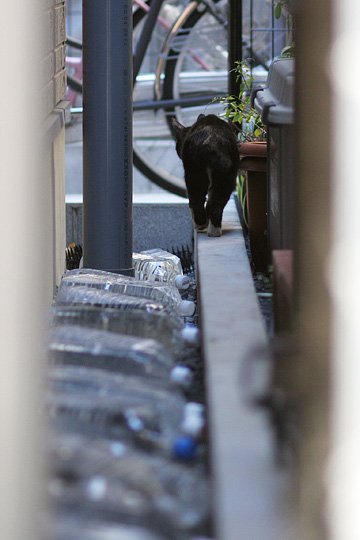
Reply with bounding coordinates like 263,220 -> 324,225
68,0 -> 282,197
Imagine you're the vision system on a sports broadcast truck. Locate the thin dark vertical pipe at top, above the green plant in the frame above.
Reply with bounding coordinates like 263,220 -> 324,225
228,0 -> 243,96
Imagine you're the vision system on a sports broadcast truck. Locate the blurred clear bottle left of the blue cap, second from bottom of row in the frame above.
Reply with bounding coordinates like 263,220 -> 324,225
46,366 -> 185,454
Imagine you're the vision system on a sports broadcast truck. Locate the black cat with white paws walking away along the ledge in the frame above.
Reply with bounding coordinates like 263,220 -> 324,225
173,114 -> 239,236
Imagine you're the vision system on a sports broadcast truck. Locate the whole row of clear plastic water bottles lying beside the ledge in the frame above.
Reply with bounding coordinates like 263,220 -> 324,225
46,250 -> 210,540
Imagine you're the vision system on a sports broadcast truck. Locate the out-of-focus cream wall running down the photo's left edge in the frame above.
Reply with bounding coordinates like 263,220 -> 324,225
0,0 -> 65,540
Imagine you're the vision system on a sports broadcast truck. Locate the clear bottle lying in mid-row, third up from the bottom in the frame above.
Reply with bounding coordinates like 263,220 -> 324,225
48,325 -> 175,385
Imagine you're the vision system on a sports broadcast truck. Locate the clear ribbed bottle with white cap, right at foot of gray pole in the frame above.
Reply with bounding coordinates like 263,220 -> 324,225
59,268 -> 195,317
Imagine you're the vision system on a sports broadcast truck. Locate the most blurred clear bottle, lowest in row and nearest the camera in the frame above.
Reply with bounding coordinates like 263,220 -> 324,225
49,433 -> 209,539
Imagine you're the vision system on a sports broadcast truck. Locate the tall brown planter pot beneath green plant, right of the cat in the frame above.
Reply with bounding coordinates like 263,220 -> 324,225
239,142 -> 269,272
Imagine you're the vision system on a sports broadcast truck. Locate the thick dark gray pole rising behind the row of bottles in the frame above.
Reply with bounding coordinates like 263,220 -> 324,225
83,0 -> 132,274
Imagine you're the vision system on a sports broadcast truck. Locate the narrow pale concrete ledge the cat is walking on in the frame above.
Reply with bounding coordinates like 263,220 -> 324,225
195,199 -> 297,540
